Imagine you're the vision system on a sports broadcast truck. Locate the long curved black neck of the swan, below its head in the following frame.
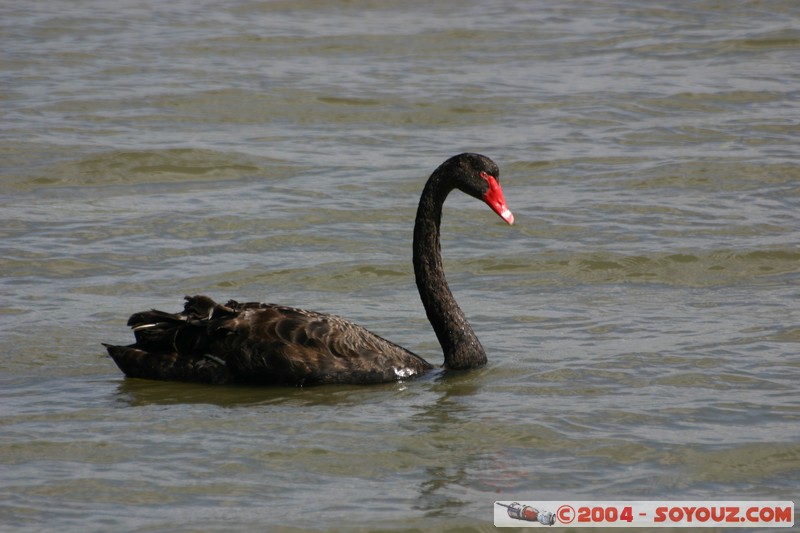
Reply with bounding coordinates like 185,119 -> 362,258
414,168 -> 486,369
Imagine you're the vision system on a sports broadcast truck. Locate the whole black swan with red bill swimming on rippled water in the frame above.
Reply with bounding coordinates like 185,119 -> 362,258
104,153 -> 514,386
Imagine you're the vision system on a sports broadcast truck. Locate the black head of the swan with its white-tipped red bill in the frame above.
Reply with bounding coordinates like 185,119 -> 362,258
440,153 -> 514,224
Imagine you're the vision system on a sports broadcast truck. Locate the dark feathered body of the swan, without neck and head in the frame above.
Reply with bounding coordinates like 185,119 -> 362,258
106,296 -> 431,385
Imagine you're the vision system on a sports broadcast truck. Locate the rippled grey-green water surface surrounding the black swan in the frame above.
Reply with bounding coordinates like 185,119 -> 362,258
0,0 -> 800,531
